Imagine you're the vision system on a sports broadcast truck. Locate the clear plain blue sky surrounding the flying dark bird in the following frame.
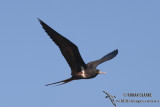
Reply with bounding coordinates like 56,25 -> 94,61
0,0 -> 160,107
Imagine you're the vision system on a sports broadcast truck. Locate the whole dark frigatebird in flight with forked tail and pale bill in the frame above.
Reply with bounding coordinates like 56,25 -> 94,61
38,19 -> 118,86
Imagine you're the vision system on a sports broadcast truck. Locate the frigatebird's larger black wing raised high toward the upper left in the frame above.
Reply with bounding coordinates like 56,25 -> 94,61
39,19 -> 86,75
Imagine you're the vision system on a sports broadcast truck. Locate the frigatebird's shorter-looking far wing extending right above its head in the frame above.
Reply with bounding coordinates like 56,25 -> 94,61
87,49 -> 118,68
